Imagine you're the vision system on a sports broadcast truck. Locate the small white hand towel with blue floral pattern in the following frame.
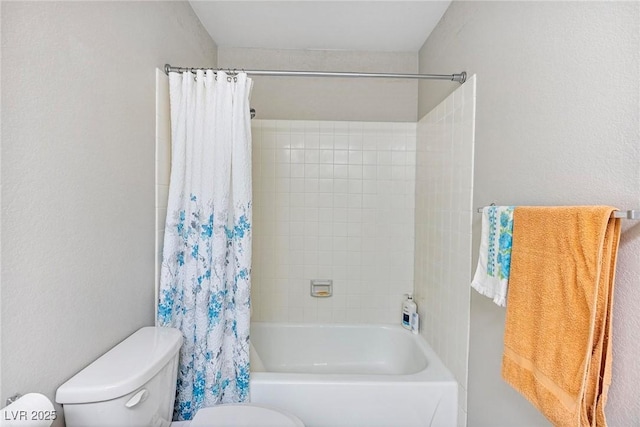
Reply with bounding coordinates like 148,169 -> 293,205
471,206 -> 514,307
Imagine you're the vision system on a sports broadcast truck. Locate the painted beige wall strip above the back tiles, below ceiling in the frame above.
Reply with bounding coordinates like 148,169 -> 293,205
218,47 -> 418,122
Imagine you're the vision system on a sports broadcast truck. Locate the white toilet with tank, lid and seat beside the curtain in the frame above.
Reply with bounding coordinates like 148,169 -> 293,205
56,327 -> 304,427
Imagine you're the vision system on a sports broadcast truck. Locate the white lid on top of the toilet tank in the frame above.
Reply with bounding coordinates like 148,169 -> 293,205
56,326 -> 182,404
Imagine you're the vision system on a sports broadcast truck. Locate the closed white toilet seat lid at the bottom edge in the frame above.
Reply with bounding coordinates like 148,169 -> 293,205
189,403 -> 304,427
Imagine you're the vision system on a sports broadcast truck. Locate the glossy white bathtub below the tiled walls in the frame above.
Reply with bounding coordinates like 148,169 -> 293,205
250,323 -> 458,427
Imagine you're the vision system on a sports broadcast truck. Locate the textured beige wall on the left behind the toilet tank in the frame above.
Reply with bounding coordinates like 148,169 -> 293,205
0,2 -> 217,422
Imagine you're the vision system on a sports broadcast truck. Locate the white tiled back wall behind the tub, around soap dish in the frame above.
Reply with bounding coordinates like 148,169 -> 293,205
252,120 -> 416,323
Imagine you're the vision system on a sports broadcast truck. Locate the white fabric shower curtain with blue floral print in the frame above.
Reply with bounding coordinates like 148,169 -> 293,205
157,70 -> 251,420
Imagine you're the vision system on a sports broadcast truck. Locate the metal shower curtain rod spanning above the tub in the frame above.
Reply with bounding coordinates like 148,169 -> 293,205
164,64 -> 467,84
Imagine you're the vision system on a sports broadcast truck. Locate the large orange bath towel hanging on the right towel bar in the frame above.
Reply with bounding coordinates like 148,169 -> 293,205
502,206 -> 620,427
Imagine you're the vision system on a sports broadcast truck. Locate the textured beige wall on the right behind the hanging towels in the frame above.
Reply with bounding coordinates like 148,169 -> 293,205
419,2 -> 640,427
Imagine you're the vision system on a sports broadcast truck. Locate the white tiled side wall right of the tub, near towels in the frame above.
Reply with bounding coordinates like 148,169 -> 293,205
415,76 -> 476,426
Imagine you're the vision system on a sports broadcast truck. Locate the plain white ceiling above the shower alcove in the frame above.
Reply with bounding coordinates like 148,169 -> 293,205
190,0 -> 451,52
